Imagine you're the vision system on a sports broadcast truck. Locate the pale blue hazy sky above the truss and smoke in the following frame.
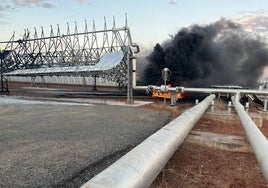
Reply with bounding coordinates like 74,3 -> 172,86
0,0 -> 268,46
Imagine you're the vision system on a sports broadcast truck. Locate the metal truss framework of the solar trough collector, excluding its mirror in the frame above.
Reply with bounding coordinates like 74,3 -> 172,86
0,18 -> 139,100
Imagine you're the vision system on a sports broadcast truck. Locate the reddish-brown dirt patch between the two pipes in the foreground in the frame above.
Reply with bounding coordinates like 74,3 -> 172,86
151,143 -> 267,188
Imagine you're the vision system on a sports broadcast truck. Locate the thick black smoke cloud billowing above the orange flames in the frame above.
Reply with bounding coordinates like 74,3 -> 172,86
143,20 -> 268,87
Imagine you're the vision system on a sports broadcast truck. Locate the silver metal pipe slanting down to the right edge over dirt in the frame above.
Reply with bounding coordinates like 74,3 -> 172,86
232,94 -> 268,183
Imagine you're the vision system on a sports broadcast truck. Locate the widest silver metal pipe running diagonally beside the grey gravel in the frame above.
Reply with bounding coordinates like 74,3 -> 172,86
82,95 -> 215,188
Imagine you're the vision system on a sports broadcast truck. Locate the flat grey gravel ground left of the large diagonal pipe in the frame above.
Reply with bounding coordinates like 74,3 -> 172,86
0,98 -> 171,187
